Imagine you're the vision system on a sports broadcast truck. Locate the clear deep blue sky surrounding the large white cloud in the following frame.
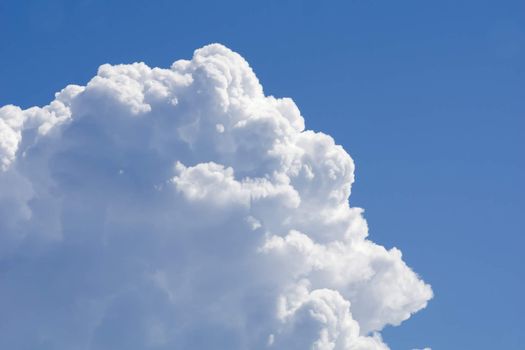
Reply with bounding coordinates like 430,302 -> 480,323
0,0 -> 525,349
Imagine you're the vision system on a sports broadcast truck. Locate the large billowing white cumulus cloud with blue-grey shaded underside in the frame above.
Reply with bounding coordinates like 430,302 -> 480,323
0,44 -> 432,350
